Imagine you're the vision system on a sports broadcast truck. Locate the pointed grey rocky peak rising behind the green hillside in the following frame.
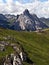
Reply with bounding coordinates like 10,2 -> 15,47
11,9 -> 48,31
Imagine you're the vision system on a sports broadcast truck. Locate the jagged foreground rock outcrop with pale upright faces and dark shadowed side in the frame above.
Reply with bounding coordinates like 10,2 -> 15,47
4,40 -> 33,65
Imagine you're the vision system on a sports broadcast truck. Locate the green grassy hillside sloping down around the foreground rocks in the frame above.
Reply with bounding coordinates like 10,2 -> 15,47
0,28 -> 49,65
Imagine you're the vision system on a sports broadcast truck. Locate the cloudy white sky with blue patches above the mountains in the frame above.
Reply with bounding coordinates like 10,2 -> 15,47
0,0 -> 49,18
